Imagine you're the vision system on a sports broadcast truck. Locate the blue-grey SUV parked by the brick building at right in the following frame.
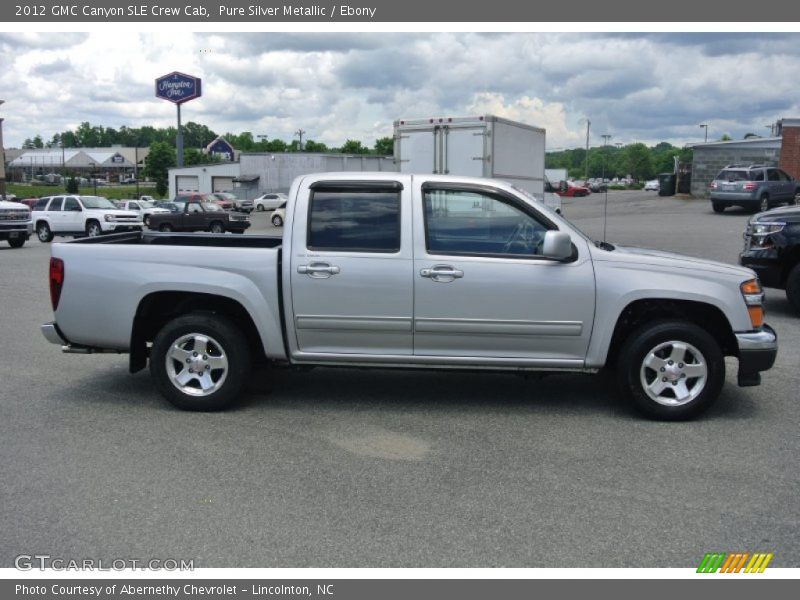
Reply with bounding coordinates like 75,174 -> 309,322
710,165 -> 800,213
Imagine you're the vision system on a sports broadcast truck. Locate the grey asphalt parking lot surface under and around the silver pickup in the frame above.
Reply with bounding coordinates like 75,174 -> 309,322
0,192 -> 800,567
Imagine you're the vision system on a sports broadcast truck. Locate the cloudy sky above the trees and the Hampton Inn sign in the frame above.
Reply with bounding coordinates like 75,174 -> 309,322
0,30 -> 800,150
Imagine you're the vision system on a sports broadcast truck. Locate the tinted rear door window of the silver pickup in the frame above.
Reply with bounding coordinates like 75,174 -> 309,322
307,189 -> 400,252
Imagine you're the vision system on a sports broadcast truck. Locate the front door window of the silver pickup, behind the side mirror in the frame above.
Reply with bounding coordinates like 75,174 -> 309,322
423,189 -> 547,257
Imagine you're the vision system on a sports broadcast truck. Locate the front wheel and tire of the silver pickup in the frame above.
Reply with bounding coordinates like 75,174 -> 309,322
617,321 -> 725,421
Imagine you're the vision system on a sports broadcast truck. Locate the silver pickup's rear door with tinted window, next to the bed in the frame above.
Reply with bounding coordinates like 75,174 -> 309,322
284,177 -> 413,361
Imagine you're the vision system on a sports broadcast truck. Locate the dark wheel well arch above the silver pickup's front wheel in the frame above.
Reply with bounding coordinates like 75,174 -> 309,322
606,299 -> 738,365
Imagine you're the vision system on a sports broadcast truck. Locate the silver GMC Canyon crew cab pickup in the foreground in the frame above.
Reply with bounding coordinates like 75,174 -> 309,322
42,173 -> 777,420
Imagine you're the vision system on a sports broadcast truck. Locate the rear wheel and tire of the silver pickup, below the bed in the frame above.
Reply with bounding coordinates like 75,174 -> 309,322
150,312 -> 251,411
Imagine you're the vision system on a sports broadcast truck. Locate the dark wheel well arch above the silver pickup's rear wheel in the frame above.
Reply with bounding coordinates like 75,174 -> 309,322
130,292 -> 266,373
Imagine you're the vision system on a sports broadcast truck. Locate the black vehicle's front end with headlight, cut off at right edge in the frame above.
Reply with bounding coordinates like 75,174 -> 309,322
739,206 -> 800,314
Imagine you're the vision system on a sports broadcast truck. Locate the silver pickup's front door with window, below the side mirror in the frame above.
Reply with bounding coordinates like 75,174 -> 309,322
414,184 -> 595,367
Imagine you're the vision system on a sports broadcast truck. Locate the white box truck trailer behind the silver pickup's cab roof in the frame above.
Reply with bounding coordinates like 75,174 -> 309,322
394,115 -> 561,212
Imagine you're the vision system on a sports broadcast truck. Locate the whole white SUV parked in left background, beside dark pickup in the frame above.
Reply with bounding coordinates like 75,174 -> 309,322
31,195 -> 143,242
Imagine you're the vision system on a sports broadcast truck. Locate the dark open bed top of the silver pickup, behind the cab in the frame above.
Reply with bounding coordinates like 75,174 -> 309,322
66,231 -> 283,248
